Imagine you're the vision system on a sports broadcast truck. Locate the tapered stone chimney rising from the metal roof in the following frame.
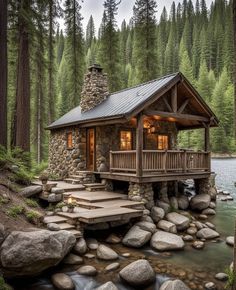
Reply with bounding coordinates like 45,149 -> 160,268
80,64 -> 109,112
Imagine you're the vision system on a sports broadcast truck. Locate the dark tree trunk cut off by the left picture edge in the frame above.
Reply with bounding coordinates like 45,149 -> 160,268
0,0 -> 7,147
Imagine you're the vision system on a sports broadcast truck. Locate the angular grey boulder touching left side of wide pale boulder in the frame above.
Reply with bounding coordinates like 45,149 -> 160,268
122,226 -> 152,248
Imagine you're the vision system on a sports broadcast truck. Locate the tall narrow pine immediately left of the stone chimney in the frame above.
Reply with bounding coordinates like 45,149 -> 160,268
64,0 -> 85,109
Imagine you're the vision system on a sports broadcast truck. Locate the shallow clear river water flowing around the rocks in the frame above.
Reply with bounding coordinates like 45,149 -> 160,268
14,159 -> 236,290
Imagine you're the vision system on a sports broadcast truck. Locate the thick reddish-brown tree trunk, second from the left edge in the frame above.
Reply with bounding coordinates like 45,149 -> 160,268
16,0 -> 30,151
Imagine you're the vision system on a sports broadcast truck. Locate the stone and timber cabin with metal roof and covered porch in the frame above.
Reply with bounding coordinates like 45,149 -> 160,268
48,64 -> 218,208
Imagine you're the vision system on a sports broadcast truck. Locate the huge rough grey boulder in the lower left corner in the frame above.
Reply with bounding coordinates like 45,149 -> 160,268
0,230 -> 76,277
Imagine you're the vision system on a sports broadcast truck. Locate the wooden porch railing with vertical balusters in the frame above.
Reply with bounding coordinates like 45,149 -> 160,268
110,150 -> 210,173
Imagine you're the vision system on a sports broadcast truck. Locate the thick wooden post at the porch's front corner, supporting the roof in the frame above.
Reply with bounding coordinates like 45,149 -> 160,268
136,113 -> 144,177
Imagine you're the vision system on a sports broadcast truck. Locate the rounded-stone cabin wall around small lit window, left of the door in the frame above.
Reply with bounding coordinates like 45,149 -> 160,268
48,127 -> 86,177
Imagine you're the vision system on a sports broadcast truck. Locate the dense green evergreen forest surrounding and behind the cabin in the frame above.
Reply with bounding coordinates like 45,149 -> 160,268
0,0 -> 236,163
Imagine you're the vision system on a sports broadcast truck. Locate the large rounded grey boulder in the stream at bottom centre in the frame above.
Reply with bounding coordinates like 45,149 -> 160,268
119,259 -> 156,289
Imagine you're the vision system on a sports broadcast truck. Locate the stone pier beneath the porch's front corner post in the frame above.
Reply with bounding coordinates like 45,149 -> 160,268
128,182 -> 154,209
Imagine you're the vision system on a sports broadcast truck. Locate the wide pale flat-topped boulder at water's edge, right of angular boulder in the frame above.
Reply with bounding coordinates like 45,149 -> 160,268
151,231 -> 184,251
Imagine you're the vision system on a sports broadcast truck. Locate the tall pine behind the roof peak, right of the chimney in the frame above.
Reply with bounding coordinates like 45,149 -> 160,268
133,0 -> 157,83
